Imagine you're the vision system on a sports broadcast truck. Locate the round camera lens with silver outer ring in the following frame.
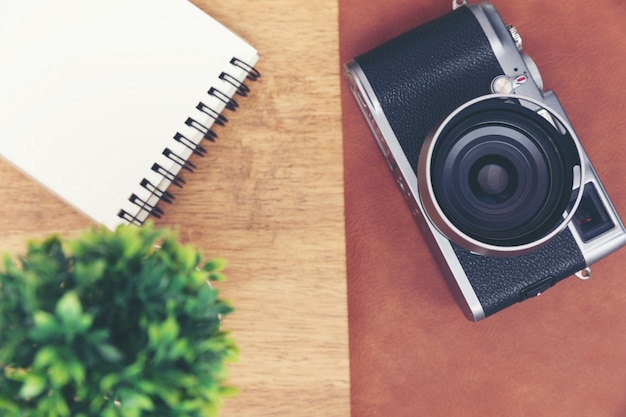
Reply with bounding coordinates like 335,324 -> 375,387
418,96 -> 582,254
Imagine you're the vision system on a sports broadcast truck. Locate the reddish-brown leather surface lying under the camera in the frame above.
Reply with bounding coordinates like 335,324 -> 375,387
339,0 -> 626,417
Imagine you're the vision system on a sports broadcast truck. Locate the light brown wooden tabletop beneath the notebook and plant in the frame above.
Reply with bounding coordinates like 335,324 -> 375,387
0,0 -> 350,417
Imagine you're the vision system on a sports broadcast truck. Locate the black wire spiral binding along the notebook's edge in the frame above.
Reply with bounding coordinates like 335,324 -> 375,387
118,57 -> 261,226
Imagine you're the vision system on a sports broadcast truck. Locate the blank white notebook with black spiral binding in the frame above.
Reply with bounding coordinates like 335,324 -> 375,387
0,0 -> 259,228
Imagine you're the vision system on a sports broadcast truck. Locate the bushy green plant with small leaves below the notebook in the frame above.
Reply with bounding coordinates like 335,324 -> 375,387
0,224 -> 237,417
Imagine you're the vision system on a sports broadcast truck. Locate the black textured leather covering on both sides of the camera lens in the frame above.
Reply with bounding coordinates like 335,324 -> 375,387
355,7 -> 586,316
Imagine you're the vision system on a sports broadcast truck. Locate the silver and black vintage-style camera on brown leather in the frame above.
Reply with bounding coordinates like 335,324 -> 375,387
344,2 -> 626,321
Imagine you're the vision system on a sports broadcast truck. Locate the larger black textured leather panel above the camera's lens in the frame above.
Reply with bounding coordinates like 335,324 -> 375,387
355,7 -> 503,171
